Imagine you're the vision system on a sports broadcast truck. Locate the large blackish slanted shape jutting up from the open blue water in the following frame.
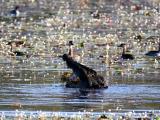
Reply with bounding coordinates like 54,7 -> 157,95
62,54 -> 107,89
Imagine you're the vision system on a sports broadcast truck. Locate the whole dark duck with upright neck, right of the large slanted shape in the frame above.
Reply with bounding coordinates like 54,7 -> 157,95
118,43 -> 134,60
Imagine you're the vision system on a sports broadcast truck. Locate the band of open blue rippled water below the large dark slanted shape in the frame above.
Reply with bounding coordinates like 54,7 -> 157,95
0,83 -> 160,111
